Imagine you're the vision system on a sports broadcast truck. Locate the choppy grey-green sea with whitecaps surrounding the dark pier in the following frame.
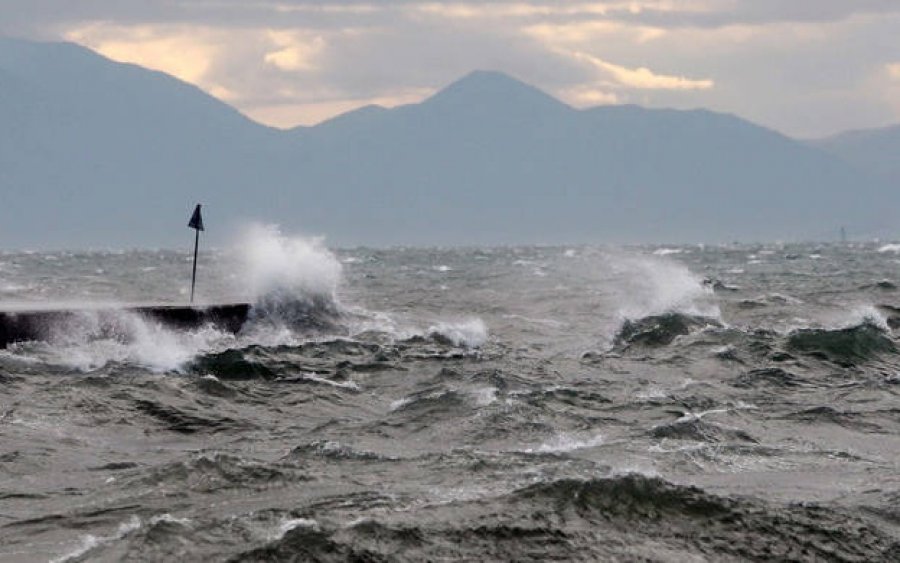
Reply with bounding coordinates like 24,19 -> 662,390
0,233 -> 900,561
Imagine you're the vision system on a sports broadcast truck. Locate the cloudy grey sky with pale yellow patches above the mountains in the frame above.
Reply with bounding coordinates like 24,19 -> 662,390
0,0 -> 900,138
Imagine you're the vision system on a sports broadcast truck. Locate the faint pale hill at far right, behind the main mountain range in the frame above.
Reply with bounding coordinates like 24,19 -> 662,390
812,125 -> 900,185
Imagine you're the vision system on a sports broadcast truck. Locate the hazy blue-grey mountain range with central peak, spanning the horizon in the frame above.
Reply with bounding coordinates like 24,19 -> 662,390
0,39 -> 900,248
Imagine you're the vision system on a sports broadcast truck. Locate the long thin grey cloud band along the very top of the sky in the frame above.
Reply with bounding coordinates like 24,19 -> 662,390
0,0 -> 900,35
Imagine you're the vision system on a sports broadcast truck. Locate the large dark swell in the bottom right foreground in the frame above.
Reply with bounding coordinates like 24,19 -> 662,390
502,474 -> 898,560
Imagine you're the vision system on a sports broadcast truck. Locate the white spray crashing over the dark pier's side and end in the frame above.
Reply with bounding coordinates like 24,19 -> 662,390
2,226 -> 341,372
